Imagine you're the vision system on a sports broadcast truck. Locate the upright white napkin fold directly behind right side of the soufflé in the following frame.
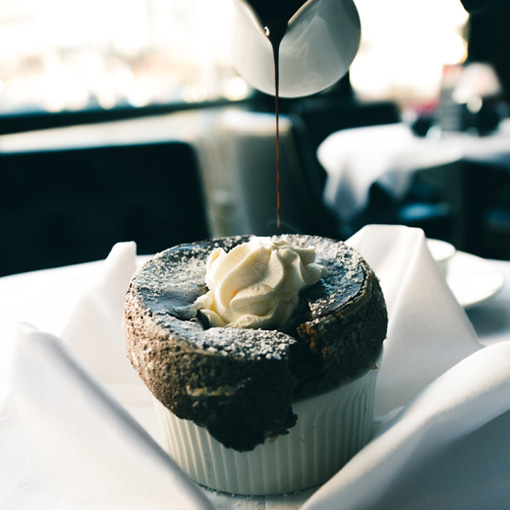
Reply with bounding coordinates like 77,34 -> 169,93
347,225 -> 481,415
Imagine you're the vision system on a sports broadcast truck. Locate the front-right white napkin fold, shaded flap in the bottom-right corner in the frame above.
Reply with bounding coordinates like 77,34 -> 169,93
303,342 -> 510,510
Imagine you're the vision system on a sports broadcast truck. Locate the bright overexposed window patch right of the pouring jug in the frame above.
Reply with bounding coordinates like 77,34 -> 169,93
351,0 -> 468,106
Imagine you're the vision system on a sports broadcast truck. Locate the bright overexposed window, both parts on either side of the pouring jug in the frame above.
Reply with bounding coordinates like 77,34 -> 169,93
0,0 -> 468,114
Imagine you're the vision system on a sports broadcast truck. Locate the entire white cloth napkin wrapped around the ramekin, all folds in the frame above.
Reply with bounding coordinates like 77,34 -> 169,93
0,226 -> 510,510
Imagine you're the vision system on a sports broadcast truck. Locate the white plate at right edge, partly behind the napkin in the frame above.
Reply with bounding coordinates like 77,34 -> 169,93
446,251 -> 504,309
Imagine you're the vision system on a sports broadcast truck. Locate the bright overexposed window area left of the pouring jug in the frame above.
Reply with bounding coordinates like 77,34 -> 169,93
0,0 -> 249,113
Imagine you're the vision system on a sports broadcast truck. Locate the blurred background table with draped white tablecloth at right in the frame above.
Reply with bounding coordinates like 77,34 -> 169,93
318,119 -> 510,258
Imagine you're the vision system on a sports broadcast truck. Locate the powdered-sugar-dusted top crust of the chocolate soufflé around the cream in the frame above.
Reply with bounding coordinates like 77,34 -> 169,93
127,235 -> 368,359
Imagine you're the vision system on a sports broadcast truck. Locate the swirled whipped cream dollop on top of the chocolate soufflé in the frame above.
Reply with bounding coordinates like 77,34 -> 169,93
193,236 -> 326,329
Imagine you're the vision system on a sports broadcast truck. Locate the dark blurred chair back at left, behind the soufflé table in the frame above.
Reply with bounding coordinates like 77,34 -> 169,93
0,141 -> 208,275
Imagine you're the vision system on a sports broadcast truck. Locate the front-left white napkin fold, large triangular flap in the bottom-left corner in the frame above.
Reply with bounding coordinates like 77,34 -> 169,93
4,325 -> 211,510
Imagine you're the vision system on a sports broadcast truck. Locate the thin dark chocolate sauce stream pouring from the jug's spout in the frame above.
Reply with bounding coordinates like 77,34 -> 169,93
249,0 -> 306,229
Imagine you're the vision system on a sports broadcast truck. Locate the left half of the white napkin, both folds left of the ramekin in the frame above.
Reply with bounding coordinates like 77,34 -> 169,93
0,243 -> 211,510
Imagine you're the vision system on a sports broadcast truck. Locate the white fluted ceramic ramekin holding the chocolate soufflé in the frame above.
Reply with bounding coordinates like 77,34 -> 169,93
154,352 -> 378,495
